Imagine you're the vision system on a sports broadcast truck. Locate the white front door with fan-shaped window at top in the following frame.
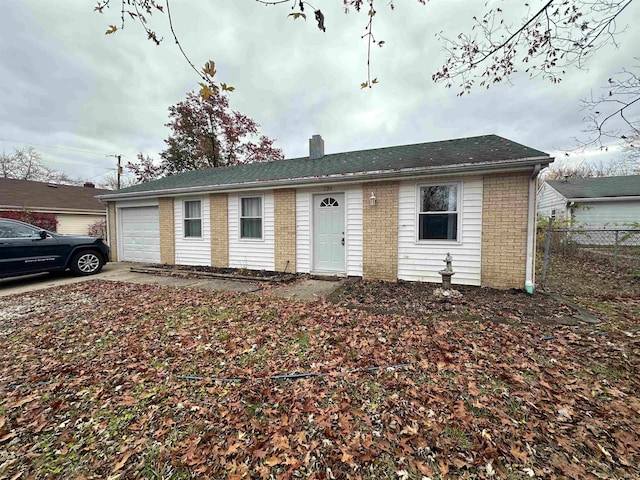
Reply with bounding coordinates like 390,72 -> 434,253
313,193 -> 346,272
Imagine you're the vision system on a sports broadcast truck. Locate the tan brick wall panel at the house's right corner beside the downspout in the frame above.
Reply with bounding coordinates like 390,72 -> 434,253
481,173 -> 530,288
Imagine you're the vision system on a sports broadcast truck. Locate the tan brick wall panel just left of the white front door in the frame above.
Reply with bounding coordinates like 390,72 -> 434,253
273,189 -> 296,272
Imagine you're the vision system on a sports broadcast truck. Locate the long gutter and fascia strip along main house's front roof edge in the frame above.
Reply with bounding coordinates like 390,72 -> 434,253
97,156 -> 553,201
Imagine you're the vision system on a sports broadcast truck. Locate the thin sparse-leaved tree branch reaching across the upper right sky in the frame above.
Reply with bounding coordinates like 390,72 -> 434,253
432,0 -> 633,95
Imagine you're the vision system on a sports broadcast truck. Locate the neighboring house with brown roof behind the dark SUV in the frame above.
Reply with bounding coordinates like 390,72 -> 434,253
0,178 -> 110,235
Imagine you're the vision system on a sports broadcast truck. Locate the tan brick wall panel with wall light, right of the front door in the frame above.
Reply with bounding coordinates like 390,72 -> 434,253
362,182 -> 399,282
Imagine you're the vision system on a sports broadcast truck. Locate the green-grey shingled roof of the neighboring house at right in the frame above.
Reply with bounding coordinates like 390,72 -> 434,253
547,175 -> 640,198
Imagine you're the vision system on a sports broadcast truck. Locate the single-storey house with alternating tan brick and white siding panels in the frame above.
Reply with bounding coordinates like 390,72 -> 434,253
100,135 -> 553,291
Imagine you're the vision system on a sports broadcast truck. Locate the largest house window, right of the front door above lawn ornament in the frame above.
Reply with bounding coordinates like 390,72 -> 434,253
418,183 -> 460,241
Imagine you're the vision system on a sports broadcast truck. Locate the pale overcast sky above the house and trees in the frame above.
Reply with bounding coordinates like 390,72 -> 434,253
0,0 -> 640,183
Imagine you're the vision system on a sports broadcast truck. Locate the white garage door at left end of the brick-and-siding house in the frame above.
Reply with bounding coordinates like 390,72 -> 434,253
120,207 -> 160,263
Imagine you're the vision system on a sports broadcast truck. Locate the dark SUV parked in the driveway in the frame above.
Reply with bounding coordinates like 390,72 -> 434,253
0,218 -> 109,278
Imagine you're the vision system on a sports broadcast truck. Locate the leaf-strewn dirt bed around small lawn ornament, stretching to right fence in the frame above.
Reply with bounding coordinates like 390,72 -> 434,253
330,256 -> 640,328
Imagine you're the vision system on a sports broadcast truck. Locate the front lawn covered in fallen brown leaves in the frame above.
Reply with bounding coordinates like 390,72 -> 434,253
0,281 -> 640,479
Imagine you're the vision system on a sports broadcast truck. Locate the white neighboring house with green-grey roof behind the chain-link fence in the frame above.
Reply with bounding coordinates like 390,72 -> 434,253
538,175 -> 640,227
